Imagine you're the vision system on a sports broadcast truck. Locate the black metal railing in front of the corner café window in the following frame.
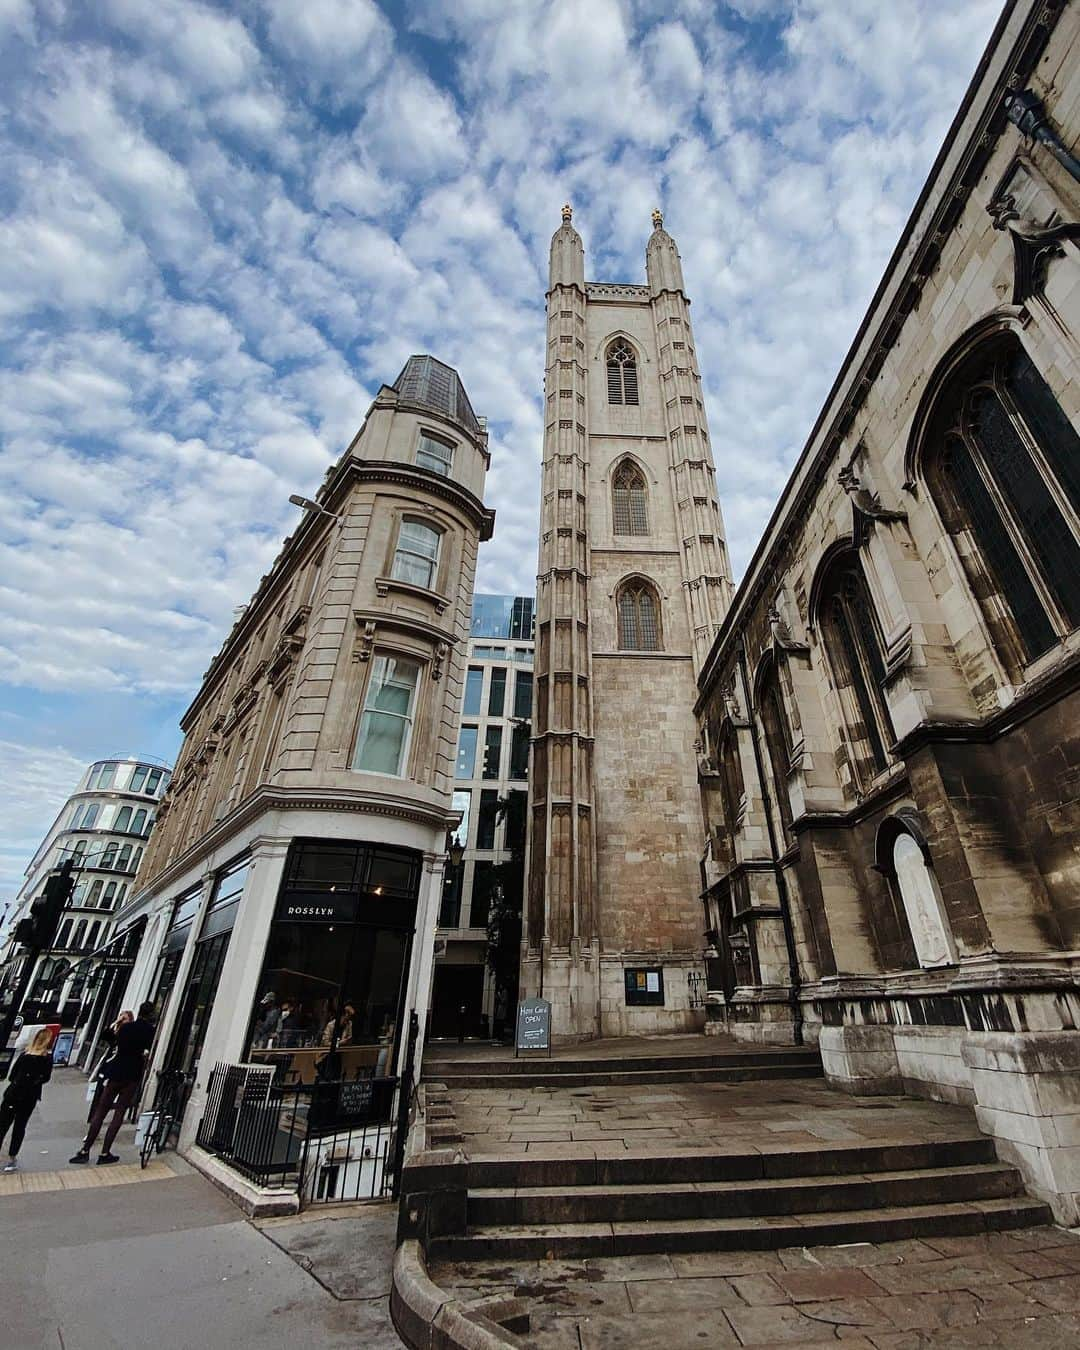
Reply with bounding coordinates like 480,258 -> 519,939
196,1019 -> 417,1204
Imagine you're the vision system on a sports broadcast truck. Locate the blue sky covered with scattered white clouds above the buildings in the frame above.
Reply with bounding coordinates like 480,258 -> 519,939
0,0 -> 999,909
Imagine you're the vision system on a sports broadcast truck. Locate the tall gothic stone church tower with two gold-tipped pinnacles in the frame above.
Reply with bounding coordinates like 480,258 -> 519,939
522,207 -> 730,1038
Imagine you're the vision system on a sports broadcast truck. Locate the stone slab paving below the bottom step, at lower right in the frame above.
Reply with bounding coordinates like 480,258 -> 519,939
431,1227 -> 1080,1350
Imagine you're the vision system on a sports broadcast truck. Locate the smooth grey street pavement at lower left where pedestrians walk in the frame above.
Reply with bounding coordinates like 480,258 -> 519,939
0,1069 -> 401,1350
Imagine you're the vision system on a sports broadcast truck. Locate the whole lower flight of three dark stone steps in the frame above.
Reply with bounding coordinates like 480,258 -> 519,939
428,1133 -> 1049,1261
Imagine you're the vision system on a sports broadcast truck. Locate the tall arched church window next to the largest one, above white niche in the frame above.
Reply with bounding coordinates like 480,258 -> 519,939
818,554 -> 894,782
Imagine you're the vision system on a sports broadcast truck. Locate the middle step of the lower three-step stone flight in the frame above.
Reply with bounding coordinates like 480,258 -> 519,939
467,1162 -> 1019,1229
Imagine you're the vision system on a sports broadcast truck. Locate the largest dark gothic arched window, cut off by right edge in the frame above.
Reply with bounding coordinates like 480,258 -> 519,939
925,336 -> 1080,670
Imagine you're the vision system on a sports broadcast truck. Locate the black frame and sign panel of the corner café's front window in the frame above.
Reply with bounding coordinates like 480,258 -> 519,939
243,838 -> 423,1076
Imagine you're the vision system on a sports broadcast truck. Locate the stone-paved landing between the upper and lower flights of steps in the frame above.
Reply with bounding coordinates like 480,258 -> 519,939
450,1079 -> 975,1157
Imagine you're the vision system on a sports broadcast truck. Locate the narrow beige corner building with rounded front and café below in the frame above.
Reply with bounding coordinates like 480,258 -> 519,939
119,356 -> 494,1161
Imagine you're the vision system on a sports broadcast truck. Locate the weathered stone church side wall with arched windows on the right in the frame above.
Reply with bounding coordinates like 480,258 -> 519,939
697,0 -> 1080,1224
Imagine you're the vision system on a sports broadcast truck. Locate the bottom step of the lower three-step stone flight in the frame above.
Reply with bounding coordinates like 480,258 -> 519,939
428,1197 -> 1049,1261
